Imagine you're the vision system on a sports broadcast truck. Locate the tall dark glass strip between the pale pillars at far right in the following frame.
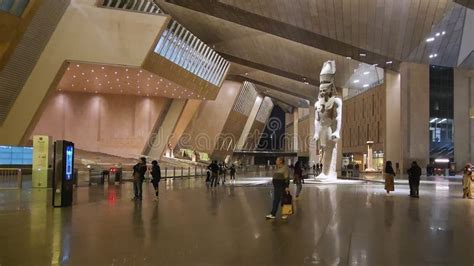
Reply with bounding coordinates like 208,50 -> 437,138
429,66 -> 454,161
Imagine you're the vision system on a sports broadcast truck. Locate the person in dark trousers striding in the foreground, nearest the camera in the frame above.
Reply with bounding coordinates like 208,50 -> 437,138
266,157 -> 290,219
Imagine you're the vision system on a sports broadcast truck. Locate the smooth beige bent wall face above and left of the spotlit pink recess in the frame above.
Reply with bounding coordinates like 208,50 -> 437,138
0,0 -> 167,145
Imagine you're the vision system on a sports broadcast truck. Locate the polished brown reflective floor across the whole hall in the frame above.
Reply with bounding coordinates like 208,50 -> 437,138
0,178 -> 474,266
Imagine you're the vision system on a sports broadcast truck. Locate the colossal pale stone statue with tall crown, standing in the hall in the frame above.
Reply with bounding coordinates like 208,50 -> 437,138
314,61 -> 342,182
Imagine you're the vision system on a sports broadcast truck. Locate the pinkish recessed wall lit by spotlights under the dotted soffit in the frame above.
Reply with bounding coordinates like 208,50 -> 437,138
30,92 -> 169,158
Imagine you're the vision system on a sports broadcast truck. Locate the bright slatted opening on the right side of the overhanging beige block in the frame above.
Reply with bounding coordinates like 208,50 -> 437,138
154,20 -> 229,86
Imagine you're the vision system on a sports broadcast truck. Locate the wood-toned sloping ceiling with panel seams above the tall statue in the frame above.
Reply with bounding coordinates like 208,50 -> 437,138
155,0 -> 471,106
